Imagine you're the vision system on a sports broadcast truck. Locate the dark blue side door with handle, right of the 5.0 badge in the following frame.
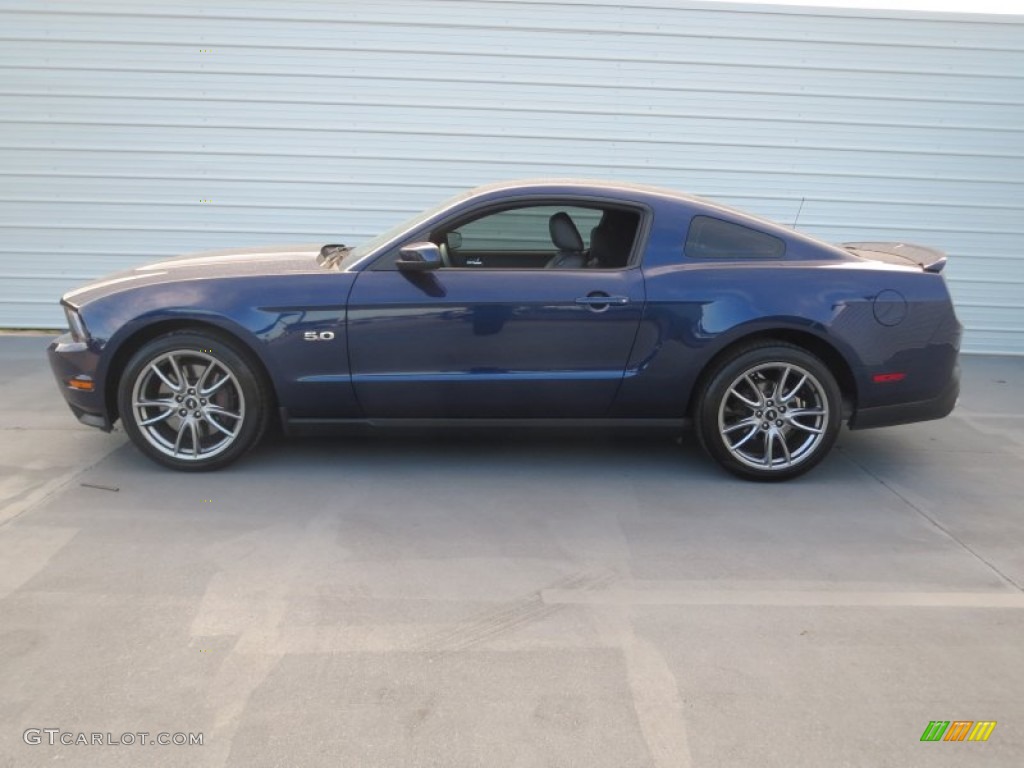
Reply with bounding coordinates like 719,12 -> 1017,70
347,201 -> 644,419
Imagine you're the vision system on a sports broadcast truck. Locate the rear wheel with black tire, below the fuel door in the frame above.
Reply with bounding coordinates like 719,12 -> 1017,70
694,342 -> 842,481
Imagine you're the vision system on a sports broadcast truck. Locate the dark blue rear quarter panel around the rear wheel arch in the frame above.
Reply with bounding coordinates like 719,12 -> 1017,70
614,196 -> 961,418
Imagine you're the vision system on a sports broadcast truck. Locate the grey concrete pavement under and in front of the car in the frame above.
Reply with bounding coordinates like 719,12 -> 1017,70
0,337 -> 1024,768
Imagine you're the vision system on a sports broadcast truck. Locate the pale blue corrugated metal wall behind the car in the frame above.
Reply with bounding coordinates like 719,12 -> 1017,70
0,0 -> 1024,353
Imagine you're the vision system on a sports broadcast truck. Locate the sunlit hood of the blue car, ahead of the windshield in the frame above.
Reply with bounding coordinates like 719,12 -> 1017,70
63,243 -> 323,306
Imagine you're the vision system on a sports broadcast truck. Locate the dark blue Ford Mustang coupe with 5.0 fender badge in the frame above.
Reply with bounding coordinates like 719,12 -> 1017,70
49,180 -> 961,480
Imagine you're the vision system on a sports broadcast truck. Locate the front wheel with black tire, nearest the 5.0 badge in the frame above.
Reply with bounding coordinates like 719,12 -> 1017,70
118,331 -> 270,471
